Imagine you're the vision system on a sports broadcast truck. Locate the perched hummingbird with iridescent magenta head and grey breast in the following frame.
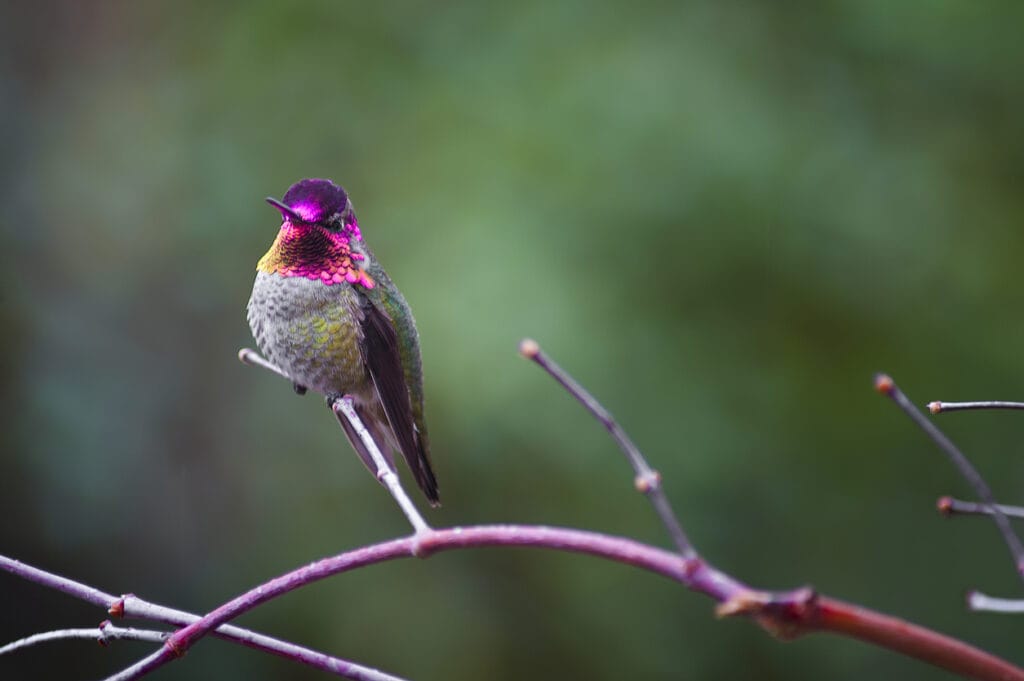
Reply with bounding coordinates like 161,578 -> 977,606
247,179 -> 440,506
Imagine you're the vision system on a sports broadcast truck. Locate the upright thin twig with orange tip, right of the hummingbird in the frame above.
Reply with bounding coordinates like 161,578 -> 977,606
519,338 -> 697,558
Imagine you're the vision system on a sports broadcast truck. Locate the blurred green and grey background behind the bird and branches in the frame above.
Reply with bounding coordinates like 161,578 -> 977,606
0,0 -> 1024,680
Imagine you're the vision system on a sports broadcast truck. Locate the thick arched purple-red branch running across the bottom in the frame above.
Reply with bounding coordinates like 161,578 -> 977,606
99,525 -> 1024,681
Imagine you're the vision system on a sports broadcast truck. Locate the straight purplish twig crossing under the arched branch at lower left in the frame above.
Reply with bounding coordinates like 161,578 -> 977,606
0,555 -> 402,681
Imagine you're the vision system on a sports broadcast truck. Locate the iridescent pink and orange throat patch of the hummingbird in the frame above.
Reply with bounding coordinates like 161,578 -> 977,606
256,220 -> 376,289
